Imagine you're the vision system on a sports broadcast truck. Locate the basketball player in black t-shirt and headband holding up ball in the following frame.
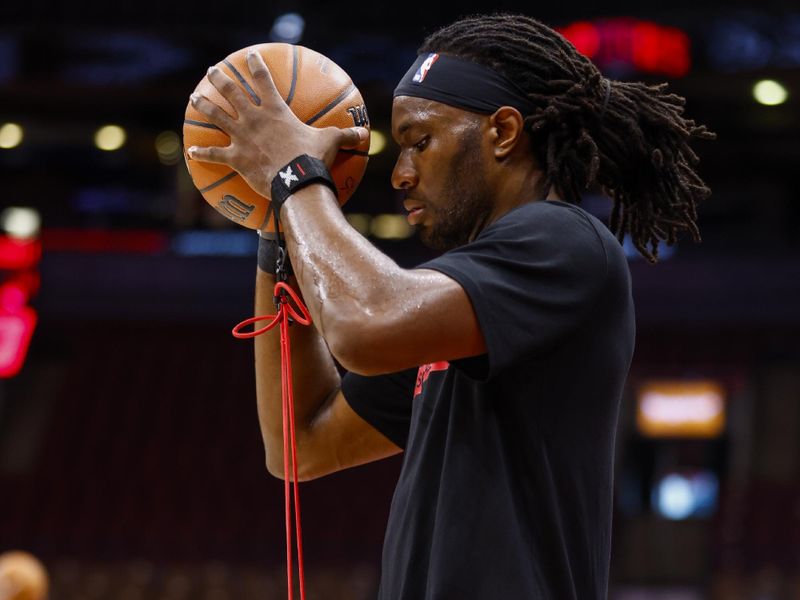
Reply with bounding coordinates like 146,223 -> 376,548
189,14 -> 713,600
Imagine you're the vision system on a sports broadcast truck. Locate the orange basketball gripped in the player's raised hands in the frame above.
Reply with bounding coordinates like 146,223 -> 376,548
183,42 -> 369,231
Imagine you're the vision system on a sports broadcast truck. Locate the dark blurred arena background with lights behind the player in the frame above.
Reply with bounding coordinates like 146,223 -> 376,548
0,0 -> 800,600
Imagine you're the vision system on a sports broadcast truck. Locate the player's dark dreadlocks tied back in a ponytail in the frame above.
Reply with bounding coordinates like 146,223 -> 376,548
419,13 -> 716,263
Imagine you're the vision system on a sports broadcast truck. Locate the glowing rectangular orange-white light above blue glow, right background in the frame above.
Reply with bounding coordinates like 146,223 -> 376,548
636,380 -> 726,438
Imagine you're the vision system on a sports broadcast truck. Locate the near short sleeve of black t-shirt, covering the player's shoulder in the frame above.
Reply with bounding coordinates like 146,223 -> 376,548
417,201 -> 607,381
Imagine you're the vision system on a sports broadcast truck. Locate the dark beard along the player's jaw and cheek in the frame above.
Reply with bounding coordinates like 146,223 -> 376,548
419,128 -> 492,251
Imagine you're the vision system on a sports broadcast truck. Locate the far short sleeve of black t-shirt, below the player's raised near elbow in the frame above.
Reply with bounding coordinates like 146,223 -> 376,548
342,368 -> 417,448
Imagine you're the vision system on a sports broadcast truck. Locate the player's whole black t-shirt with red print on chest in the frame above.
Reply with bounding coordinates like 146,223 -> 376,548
342,201 -> 635,600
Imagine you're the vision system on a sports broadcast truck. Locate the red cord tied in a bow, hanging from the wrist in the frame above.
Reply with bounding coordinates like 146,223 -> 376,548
232,281 -> 311,600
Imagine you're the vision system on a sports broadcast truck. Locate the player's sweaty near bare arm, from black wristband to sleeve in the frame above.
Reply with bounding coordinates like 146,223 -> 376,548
281,185 -> 485,375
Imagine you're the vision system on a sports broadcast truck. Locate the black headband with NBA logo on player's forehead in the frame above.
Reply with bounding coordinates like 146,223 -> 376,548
394,53 -> 537,115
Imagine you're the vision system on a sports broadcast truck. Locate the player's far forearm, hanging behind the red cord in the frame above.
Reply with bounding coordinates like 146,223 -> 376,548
254,269 -> 340,474
